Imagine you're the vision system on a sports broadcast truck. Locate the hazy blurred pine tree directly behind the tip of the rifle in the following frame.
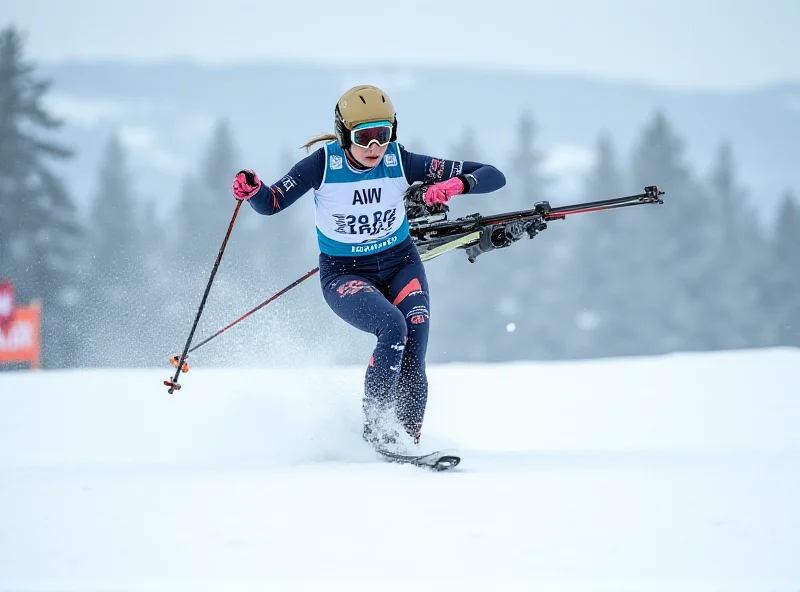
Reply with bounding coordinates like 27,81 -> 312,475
625,112 -> 714,353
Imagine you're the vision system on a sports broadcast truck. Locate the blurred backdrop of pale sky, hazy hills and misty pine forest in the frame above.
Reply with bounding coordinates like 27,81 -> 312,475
0,0 -> 800,369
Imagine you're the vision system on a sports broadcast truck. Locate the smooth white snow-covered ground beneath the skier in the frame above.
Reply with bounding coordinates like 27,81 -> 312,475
0,349 -> 800,592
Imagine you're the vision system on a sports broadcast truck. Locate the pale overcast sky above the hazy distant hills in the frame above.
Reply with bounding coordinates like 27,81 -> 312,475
0,0 -> 800,92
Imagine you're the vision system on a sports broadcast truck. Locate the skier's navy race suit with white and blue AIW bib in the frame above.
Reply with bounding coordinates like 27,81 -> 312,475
249,142 -> 505,441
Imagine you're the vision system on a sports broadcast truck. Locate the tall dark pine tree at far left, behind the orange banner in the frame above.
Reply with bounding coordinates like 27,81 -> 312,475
0,26 -> 81,367
